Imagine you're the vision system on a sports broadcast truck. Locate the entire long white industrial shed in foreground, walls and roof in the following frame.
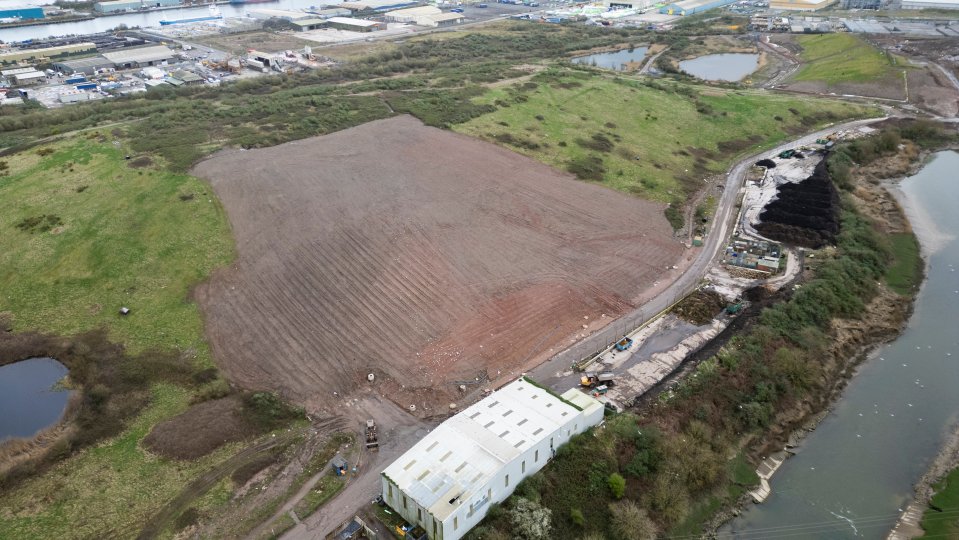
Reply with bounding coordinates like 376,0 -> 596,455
382,377 -> 603,540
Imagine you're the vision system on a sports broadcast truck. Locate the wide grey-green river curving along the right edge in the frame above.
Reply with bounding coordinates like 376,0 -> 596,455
721,152 -> 959,539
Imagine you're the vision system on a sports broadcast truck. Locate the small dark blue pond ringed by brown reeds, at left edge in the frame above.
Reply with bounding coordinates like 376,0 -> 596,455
0,358 -> 70,441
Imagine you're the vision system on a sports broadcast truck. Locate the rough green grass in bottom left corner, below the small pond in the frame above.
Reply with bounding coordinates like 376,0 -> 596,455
0,385 -> 248,538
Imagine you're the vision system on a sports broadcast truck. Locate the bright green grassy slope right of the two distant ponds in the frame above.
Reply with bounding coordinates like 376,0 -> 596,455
792,34 -> 897,85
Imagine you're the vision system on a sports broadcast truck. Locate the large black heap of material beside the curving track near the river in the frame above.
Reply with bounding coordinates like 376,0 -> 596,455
756,159 -> 839,249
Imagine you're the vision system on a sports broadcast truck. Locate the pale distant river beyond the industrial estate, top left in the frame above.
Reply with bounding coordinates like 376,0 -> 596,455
0,0 -> 326,42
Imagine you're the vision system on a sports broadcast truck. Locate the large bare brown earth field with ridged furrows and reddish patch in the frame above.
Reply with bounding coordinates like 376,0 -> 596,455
193,116 -> 683,415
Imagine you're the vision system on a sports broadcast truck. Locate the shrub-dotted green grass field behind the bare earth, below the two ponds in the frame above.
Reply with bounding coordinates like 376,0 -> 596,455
453,70 -> 871,206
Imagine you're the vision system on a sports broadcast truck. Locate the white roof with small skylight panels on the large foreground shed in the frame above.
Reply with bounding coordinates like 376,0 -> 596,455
383,378 -> 602,521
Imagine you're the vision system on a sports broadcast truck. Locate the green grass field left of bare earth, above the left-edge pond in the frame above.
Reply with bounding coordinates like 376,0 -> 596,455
0,138 -> 233,363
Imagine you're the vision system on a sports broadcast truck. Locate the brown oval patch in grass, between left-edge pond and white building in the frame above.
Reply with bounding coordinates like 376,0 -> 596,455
143,396 -> 258,459
